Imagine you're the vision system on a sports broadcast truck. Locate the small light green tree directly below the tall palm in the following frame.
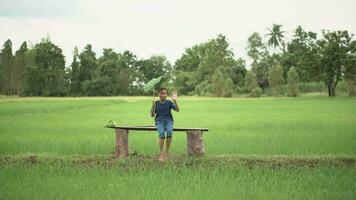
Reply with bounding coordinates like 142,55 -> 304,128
268,64 -> 284,95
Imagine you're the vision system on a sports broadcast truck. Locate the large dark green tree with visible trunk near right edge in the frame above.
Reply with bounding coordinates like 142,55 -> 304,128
313,31 -> 352,97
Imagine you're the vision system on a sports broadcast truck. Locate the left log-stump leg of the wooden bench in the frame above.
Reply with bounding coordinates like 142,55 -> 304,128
115,128 -> 129,158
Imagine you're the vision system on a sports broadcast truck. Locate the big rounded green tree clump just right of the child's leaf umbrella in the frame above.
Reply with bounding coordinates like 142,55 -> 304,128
174,34 -> 246,96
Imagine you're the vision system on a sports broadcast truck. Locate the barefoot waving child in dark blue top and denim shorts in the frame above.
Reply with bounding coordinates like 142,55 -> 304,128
151,88 -> 179,161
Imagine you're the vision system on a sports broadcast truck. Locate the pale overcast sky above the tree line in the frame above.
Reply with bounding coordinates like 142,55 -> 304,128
0,0 -> 356,66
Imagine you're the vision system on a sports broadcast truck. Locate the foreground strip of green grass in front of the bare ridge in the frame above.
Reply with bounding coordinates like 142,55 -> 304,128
0,158 -> 356,199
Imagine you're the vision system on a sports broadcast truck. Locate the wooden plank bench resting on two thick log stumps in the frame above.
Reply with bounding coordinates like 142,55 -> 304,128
107,126 -> 208,158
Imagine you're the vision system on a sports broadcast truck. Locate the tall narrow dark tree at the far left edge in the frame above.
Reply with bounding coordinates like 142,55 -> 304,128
0,39 -> 14,95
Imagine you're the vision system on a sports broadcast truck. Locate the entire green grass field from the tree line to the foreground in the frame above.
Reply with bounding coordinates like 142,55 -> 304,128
0,95 -> 356,199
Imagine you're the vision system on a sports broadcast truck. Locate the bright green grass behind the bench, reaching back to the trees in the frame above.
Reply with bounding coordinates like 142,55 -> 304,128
0,97 -> 356,156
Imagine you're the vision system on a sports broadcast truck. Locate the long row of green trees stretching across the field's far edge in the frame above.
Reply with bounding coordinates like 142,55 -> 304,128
0,24 -> 356,97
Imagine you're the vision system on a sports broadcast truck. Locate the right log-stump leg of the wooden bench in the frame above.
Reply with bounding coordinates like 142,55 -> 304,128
187,130 -> 204,156
